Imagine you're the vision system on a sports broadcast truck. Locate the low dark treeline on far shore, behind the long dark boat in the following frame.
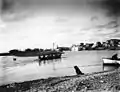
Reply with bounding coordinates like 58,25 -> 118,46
0,47 -> 70,56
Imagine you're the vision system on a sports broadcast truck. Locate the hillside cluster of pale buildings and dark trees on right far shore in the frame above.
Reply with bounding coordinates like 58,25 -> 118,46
70,39 -> 120,51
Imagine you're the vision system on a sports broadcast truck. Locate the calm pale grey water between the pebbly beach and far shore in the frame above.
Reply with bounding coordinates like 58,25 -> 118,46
0,51 -> 120,85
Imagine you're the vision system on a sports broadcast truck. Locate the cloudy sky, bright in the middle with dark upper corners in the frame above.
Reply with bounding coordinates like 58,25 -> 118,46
0,0 -> 120,52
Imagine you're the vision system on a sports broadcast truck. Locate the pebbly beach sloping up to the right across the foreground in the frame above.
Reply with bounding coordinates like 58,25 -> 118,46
0,68 -> 120,92
